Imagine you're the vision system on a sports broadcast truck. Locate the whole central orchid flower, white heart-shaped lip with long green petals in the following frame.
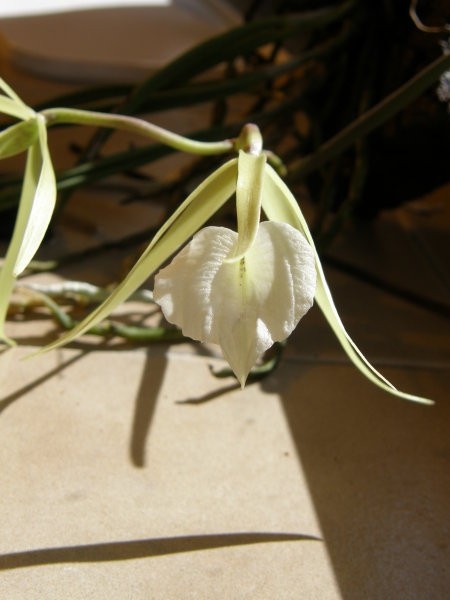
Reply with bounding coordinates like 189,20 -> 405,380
38,123 -> 432,404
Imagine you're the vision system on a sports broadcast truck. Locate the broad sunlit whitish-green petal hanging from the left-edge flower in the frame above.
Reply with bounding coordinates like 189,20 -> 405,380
13,117 -> 56,277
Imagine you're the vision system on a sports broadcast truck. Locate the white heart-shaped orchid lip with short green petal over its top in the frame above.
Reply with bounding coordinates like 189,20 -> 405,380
153,150 -> 316,387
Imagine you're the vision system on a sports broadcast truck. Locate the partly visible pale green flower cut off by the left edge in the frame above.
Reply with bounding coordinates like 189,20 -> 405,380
0,78 -> 56,344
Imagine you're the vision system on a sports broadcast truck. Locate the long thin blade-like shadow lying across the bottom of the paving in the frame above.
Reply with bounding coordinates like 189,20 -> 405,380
0,532 -> 321,570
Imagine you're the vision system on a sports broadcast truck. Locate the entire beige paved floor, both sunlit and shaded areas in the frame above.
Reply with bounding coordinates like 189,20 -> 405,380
0,253 -> 450,599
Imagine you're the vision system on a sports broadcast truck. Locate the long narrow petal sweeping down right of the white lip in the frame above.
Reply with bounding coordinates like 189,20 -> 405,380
262,165 -> 433,404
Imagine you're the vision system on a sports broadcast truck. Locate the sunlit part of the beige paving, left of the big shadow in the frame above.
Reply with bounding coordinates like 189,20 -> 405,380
0,344 -> 334,598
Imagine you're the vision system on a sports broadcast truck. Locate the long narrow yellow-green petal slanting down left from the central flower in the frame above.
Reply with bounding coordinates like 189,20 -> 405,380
37,159 -> 237,352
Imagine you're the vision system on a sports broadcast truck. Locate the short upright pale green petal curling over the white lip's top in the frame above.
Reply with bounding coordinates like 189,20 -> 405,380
232,150 -> 266,261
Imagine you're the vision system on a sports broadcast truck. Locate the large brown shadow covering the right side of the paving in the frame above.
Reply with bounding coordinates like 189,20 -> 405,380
274,364 -> 450,600
